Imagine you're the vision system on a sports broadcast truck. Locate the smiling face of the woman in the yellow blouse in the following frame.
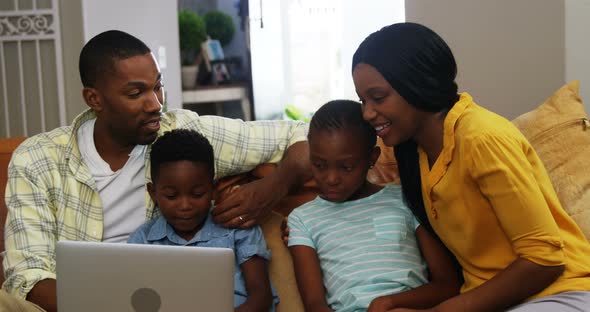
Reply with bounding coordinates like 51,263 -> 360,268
352,63 -> 425,146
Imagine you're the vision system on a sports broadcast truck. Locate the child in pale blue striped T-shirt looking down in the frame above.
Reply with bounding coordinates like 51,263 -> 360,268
288,100 -> 460,311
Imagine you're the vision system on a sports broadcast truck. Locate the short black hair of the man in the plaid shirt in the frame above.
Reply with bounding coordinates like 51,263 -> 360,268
78,30 -> 151,88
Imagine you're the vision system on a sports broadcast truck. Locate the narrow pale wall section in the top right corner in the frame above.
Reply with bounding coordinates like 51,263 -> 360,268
565,0 -> 590,113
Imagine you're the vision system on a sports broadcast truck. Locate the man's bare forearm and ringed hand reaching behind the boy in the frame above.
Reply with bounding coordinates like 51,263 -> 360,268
213,141 -> 311,227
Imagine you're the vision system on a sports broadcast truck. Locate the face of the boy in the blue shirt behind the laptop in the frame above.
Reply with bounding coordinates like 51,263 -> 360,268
148,160 -> 213,240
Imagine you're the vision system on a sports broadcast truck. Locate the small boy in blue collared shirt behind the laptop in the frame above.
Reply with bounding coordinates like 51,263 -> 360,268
128,129 -> 274,311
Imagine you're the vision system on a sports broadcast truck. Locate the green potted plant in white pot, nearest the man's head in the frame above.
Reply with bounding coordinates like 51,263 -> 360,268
178,10 -> 207,89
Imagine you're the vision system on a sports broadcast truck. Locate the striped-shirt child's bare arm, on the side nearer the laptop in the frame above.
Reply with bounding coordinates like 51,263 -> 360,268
289,245 -> 332,312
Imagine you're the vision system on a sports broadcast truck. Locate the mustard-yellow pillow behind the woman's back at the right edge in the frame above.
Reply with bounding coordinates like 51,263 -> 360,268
512,80 -> 590,240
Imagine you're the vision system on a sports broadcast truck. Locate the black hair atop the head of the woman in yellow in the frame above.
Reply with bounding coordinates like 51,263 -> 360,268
352,23 -> 457,112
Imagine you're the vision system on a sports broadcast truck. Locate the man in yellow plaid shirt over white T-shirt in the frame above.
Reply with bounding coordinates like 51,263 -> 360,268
0,31 -> 308,311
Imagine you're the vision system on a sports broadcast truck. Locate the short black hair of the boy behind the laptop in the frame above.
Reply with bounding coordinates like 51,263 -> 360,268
150,129 -> 215,182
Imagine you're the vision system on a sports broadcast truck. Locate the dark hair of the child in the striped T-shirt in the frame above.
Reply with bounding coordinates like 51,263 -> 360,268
307,100 -> 377,149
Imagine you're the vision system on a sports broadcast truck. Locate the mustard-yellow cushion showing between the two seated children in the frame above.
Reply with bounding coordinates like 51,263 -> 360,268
260,212 -> 304,312
